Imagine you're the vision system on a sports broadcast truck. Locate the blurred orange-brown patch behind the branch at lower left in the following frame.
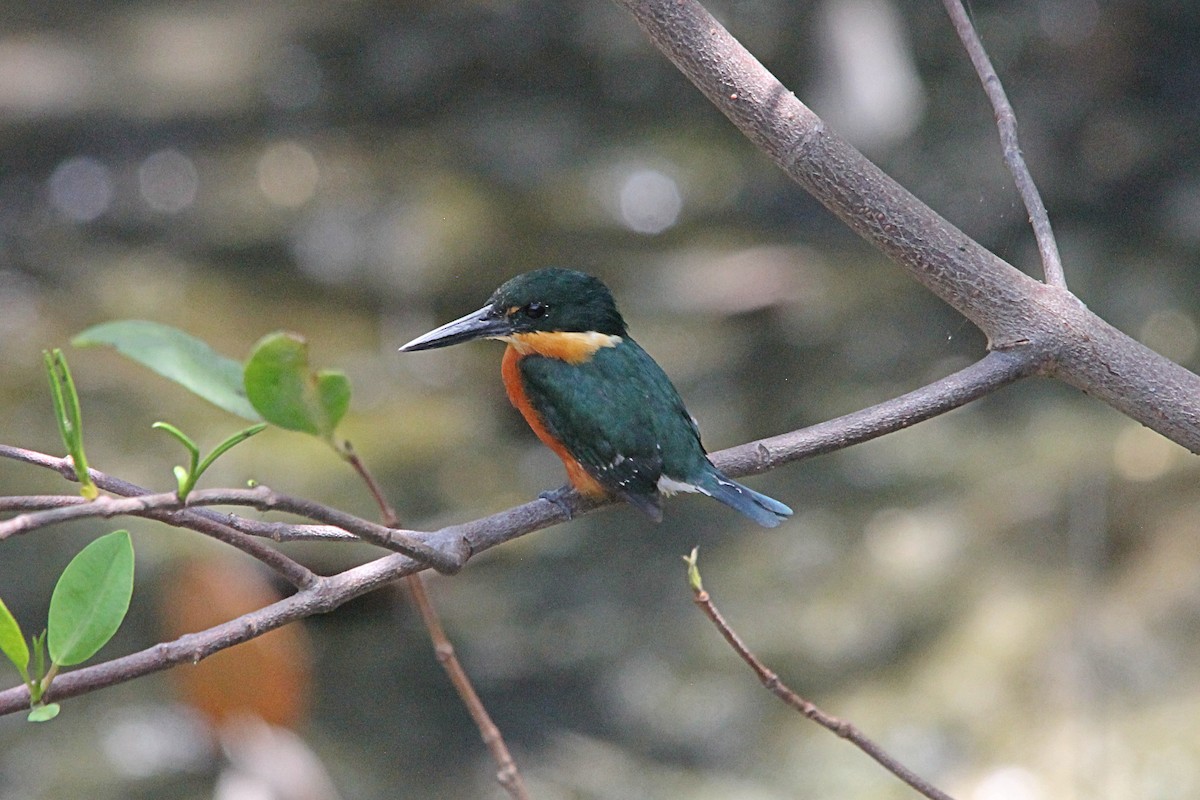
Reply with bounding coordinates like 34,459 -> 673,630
162,558 -> 311,728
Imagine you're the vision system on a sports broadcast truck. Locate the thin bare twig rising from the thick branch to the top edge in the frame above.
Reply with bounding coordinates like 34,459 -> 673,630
943,0 -> 1067,289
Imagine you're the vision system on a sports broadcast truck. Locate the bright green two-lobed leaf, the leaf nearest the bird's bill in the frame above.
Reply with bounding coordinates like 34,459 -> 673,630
245,332 -> 350,440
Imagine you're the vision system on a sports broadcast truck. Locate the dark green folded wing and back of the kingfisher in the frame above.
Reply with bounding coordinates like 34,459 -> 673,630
521,338 -> 706,517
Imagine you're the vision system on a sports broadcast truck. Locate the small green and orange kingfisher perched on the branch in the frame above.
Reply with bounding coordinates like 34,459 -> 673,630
400,269 -> 792,528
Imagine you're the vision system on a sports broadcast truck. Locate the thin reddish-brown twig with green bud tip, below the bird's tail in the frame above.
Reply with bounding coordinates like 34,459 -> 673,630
684,549 -> 953,800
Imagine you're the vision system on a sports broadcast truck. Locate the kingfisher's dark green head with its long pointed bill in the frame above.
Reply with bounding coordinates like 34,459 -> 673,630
400,267 -> 625,353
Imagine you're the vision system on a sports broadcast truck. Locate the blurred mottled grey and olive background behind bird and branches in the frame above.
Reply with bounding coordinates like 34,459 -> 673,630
0,0 -> 1200,800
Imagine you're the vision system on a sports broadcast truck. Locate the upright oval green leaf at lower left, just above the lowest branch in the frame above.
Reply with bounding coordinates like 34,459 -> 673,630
48,530 -> 133,667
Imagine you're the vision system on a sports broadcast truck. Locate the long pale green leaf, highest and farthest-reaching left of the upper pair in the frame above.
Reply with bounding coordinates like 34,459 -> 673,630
71,319 -> 262,422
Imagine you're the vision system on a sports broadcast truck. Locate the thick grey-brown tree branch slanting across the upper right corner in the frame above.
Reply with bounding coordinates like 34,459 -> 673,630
617,0 -> 1200,453
